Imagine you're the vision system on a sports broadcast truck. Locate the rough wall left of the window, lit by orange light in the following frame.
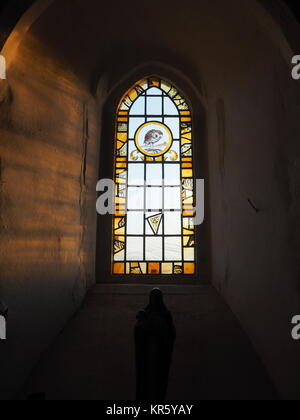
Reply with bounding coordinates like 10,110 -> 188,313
0,37 -> 99,398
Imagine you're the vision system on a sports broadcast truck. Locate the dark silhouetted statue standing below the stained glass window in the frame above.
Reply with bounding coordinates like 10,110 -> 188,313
135,289 -> 176,402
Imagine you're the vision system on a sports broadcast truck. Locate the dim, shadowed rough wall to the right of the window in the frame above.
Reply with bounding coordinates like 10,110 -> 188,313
209,35 -> 300,399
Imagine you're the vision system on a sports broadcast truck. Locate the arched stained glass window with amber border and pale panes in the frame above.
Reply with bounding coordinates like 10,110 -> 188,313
112,77 -> 196,275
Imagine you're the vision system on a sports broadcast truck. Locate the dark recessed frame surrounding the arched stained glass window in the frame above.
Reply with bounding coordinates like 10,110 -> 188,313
96,71 -> 210,285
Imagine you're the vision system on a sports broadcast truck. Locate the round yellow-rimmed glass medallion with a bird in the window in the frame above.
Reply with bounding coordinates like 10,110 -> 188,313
135,122 -> 173,157
